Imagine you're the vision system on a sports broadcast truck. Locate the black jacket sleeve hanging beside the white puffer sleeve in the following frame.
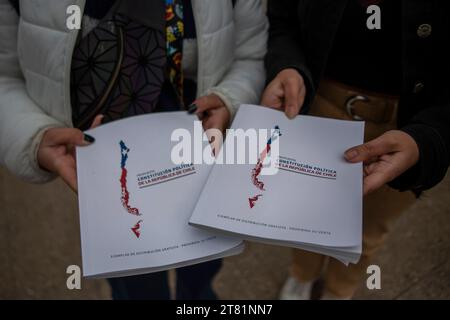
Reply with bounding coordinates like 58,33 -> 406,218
266,0 -> 316,111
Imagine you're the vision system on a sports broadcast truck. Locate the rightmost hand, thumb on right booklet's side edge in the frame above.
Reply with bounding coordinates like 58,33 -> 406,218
345,130 -> 419,195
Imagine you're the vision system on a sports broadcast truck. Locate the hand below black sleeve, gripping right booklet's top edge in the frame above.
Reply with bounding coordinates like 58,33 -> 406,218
261,69 -> 306,119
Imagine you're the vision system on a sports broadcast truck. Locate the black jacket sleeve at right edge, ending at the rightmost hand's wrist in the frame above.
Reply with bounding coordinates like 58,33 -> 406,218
390,105 -> 450,193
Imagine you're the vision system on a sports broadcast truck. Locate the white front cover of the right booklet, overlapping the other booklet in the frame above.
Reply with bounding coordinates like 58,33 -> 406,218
190,106 -> 364,247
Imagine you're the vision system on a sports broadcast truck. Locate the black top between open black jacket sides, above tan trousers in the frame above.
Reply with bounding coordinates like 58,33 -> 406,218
325,0 -> 402,95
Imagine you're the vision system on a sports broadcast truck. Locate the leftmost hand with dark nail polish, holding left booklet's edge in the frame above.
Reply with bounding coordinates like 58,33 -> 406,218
37,116 -> 103,192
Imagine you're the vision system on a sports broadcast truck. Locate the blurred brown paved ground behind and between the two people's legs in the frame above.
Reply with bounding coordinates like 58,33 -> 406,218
0,169 -> 450,299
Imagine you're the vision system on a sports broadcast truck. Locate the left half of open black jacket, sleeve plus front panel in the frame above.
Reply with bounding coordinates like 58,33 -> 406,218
266,0 -> 347,112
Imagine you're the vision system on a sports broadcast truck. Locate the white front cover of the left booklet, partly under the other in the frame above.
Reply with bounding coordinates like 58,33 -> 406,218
77,112 -> 240,276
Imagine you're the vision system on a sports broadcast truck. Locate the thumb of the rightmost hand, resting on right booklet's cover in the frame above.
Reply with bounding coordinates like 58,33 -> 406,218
344,135 -> 394,163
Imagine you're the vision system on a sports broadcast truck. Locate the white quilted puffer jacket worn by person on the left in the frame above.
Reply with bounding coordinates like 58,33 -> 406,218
0,0 -> 268,183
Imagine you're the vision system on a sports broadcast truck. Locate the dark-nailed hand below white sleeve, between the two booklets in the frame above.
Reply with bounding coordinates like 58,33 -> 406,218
188,94 -> 231,154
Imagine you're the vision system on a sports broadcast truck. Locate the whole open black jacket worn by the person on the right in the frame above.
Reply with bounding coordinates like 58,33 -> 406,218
266,0 -> 450,192
